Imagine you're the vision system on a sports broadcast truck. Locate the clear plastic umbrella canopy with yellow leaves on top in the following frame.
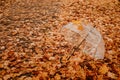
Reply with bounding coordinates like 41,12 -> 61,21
61,21 -> 105,59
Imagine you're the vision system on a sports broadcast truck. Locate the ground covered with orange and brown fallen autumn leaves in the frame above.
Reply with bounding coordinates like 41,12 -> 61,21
0,0 -> 120,80
